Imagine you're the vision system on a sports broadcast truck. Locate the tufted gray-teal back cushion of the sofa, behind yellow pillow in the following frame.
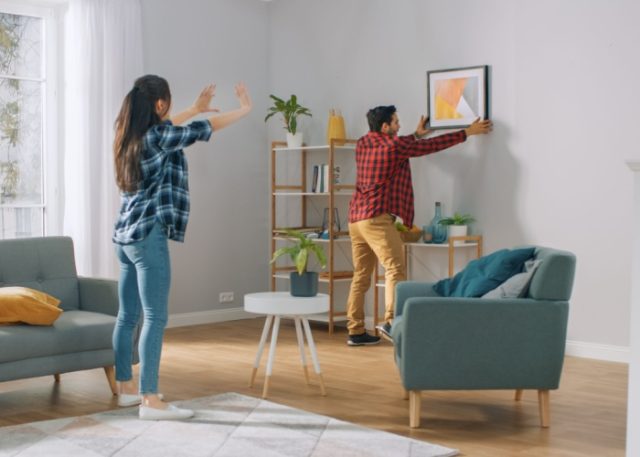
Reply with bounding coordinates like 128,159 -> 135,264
0,236 -> 79,311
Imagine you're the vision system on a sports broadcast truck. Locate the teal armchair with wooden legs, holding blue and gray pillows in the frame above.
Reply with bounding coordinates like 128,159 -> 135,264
392,247 -> 576,427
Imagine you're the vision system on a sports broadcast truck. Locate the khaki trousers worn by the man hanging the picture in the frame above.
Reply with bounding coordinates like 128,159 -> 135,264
347,214 -> 407,335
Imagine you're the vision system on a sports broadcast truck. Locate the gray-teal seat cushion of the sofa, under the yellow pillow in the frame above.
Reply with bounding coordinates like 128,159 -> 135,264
0,311 -> 116,363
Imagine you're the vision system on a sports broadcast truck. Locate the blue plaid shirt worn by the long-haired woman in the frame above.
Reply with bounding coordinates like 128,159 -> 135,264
113,120 -> 212,244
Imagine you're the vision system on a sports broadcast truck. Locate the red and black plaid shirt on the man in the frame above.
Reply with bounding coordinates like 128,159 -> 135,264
349,130 -> 467,227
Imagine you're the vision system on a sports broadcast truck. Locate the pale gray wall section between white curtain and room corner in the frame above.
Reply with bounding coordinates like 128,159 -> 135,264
142,0 -> 269,323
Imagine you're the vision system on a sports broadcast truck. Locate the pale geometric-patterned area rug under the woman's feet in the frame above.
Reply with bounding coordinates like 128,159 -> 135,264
0,393 -> 458,457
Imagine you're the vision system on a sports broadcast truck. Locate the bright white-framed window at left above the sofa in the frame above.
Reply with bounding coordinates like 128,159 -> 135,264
0,5 -> 56,239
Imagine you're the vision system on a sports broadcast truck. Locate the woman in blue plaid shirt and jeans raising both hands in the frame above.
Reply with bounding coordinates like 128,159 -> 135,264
113,75 -> 252,420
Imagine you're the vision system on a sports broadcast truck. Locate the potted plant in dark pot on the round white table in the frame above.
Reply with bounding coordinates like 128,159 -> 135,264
270,230 -> 327,297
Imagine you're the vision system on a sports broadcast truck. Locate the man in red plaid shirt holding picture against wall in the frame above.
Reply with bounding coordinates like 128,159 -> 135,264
347,106 -> 492,346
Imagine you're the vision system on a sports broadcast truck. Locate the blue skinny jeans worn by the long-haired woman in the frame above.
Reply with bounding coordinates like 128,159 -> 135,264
113,223 -> 171,394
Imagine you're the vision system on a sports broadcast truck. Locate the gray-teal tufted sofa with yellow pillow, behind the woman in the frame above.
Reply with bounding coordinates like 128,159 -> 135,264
0,237 -> 118,395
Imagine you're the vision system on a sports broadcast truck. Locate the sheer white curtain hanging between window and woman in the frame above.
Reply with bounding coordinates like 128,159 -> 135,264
64,0 -> 142,278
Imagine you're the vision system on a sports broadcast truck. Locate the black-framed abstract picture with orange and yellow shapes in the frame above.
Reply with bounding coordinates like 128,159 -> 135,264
427,65 -> 489,129
